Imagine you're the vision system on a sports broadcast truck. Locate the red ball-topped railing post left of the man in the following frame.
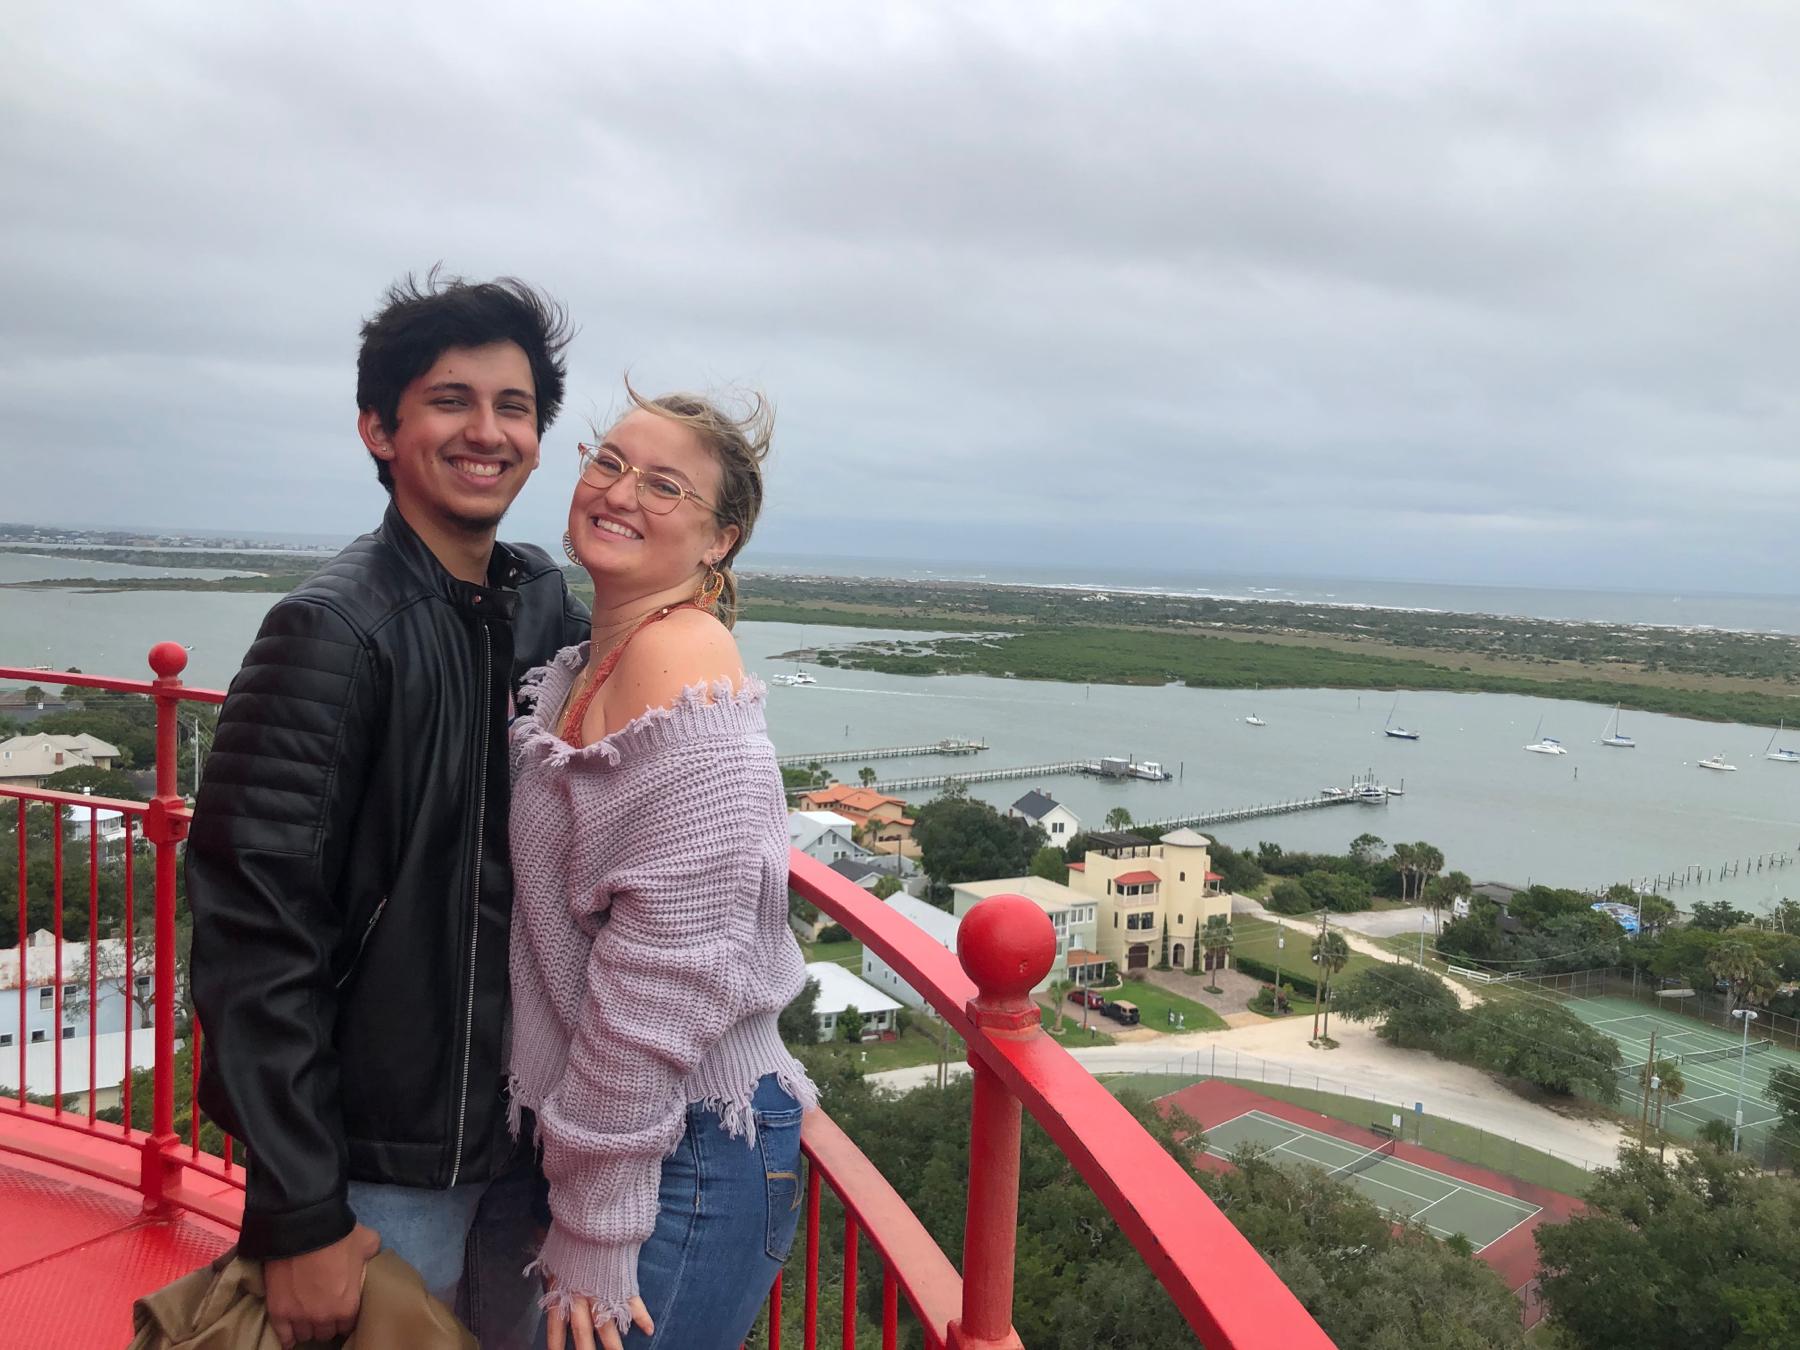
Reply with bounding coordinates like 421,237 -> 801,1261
139,643 -> 187,1210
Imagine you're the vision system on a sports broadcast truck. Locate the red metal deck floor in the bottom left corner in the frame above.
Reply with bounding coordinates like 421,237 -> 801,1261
0,1154 -> 234,1350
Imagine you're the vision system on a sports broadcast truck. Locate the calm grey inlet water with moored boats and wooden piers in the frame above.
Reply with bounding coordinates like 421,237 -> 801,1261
0,556 -> 1800,909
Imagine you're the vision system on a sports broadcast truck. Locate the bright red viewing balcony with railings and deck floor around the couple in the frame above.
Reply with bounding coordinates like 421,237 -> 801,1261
0,643 -> 1330,1350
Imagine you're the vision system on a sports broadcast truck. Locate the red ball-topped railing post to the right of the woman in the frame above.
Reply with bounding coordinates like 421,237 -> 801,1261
950,895 -> 1057,1350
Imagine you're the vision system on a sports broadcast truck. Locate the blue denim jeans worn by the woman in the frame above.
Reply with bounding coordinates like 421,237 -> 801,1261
625,1075 -> 805,1350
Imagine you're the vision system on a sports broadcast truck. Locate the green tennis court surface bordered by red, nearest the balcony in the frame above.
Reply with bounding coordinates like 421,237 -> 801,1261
1206,1111 -> 1541,1251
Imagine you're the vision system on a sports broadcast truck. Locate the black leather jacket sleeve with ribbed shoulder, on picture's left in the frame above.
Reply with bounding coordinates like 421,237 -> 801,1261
185,599 -> 382,1260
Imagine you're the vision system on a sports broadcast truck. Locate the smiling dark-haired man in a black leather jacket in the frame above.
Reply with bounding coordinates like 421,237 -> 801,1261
187,272 -> 589,1346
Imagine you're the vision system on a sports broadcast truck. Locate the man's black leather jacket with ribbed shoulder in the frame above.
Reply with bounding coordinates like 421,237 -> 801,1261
187,508 -> 589,1260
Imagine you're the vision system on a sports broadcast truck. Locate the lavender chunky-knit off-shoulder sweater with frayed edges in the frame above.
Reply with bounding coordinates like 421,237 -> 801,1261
509,644 -> 815,1330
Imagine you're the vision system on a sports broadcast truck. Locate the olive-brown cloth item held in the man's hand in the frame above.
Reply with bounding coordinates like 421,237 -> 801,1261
126,1247 -> 477,1350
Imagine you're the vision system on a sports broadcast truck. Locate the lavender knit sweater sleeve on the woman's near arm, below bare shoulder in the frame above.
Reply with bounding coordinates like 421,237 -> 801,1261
538,736 -> 787,1330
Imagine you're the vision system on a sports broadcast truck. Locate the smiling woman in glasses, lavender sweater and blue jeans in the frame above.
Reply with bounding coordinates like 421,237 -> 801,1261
511,385 -> 814,1350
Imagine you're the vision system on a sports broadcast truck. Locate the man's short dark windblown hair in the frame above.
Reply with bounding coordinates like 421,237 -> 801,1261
356,266 -> 574,493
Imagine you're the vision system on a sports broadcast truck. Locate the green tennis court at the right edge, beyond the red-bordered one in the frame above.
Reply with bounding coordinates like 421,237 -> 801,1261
1564,997 -> 1800,1134
